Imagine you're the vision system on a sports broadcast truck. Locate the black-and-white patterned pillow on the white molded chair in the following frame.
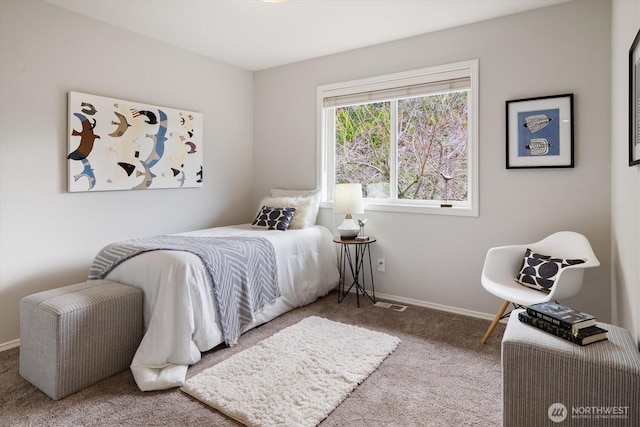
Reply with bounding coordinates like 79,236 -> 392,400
514,248 -> 584,292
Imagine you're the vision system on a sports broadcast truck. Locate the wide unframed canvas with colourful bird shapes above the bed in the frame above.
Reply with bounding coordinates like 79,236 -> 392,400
67,92 -> 203,192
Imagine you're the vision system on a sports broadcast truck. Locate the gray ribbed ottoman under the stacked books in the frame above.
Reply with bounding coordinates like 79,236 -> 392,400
502,310 -> 640,427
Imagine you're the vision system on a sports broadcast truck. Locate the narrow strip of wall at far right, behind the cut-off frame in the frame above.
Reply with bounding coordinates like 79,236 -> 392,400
611,0 -> 640,344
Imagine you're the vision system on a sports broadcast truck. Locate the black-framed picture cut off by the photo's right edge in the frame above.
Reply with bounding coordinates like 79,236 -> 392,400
629,30 -> 640,166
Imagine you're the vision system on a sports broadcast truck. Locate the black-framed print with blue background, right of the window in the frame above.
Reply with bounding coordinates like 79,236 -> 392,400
506,94 -> 573,169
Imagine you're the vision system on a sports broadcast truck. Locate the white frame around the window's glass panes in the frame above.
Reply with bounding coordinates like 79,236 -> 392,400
316,59 -> 479,217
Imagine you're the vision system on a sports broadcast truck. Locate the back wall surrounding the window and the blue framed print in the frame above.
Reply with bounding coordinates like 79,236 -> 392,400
254,0 -> 611,321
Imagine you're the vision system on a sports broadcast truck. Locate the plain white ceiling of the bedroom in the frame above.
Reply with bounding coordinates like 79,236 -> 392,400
45,0 -> 570,71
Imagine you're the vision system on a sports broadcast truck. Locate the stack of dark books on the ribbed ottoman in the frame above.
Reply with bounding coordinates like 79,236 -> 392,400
518,302 -> 607,345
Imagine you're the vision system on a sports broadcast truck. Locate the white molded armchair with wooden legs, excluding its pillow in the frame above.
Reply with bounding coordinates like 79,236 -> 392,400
481,231 -> 600,344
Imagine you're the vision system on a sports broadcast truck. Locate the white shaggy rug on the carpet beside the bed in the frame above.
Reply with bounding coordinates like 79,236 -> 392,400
182,316 -> 400,427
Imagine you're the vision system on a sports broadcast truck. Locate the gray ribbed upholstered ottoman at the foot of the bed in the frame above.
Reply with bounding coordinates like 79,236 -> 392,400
20,280 -> 144,400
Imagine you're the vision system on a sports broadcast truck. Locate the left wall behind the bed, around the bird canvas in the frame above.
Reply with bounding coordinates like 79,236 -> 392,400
0,0 -> 253,348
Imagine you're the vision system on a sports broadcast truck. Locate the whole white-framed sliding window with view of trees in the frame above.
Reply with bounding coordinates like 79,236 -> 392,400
318,60 -> 478,216
